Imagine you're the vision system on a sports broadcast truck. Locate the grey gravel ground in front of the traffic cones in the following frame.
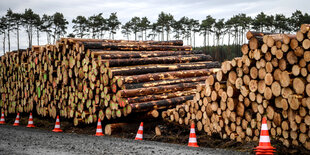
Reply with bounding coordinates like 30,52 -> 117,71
0,125 -> 247,155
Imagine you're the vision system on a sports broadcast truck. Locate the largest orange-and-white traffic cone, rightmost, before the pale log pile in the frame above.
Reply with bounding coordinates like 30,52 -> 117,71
254,117 -> 276,154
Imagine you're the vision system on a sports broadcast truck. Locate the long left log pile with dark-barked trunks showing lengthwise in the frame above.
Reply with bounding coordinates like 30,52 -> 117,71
0,38 -> 220,125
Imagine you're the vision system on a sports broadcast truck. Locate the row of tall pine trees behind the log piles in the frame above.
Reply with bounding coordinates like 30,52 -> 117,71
0,9 -> 310,51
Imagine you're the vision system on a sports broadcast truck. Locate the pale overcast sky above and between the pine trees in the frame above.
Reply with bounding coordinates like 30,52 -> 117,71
0,0 -> 310,51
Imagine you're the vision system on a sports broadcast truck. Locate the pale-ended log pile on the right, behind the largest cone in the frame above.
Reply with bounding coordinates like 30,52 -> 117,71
162,24 -> 310,150
